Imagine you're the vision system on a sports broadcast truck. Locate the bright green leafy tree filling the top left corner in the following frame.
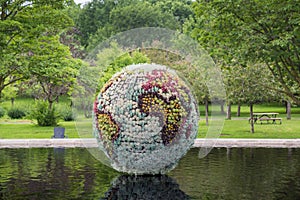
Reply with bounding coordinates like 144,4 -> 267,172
0,0 -> 72,98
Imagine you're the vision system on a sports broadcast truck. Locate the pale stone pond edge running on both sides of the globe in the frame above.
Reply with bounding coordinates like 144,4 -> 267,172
0,138 -> 300,149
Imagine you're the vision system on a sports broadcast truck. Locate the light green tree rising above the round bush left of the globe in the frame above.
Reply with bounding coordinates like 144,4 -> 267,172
29,36 -> 81,109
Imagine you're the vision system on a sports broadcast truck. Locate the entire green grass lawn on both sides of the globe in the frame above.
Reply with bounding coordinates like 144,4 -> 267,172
0,99 -> 300,139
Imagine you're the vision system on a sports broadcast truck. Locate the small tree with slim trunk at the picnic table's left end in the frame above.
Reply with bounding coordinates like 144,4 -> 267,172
224,64 -> 275,133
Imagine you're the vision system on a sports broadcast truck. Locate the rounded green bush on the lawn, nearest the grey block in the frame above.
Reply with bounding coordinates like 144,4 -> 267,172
31,101 -> 60,126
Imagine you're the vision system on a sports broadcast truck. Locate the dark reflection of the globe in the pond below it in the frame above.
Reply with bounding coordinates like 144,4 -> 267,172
101,175 -> 190,200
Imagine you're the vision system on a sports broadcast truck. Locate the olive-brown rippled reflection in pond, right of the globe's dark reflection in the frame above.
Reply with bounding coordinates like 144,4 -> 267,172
168,148 -> 300,200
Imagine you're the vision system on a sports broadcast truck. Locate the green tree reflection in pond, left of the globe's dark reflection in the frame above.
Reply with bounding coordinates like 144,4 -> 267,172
0,148 -> 118,200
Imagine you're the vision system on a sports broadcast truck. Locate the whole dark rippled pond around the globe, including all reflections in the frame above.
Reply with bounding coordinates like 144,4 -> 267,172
0,148 -> 300,200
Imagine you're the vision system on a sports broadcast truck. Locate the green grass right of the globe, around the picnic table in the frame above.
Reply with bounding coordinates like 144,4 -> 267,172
198,104 -> 300,139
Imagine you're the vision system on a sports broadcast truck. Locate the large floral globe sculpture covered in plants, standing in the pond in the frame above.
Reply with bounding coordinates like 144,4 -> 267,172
93,64 -> 199,174
